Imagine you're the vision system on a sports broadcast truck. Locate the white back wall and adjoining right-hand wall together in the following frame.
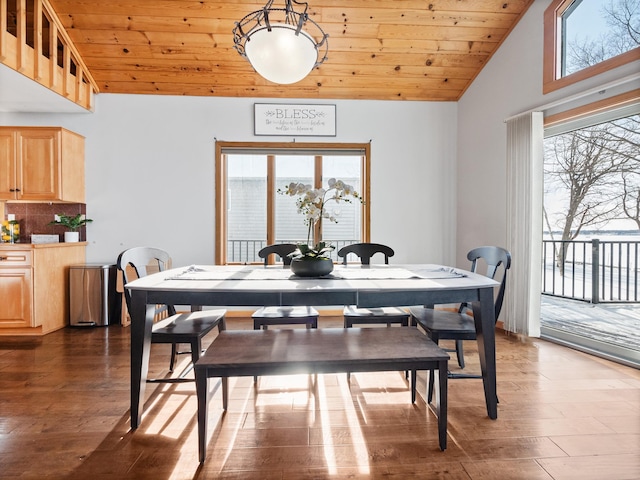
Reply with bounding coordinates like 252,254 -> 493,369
8,0 -> 640,267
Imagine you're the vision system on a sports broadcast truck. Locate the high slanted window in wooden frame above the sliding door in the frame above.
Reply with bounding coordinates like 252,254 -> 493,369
543,0 -> 640,93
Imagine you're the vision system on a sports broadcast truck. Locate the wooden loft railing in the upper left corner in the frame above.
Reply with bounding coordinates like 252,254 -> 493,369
0,0 -> 98,110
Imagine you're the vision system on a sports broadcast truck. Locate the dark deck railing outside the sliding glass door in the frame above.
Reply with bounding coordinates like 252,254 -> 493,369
542,239 -> 640,303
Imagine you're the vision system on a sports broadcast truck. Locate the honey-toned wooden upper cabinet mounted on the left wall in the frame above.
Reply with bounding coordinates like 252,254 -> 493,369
0,127 -> 85,203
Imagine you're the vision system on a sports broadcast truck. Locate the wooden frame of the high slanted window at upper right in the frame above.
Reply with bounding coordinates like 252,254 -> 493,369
542,0 -> 640,94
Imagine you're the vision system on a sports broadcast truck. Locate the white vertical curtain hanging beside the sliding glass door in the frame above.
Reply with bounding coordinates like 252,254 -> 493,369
504,112 -> 544,337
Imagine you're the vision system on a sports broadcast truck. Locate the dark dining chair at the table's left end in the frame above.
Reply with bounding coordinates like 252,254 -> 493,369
117,247 -> 227,383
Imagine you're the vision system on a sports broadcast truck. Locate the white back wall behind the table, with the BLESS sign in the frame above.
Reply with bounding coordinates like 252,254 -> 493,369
0,94 -> 457,265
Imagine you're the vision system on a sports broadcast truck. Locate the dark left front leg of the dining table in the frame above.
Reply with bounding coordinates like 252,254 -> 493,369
129,290 -> 154,430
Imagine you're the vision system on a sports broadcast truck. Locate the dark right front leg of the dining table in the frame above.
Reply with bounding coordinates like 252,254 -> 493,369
473,288 -> 498,420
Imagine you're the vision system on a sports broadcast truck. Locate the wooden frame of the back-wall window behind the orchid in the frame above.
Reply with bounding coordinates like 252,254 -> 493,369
214,141 -> 371,265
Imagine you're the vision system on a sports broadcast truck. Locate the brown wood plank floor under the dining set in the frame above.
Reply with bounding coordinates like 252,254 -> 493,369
0,318 -> 640,480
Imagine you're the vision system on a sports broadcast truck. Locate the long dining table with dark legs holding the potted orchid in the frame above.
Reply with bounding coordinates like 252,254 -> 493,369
125,264 -> 499,429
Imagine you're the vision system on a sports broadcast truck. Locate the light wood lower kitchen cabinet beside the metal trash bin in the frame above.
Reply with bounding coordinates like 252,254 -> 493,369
0,242 -> 86,335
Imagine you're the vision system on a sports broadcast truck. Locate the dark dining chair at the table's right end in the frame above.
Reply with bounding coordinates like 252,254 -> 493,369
409,246 -> 511,401
